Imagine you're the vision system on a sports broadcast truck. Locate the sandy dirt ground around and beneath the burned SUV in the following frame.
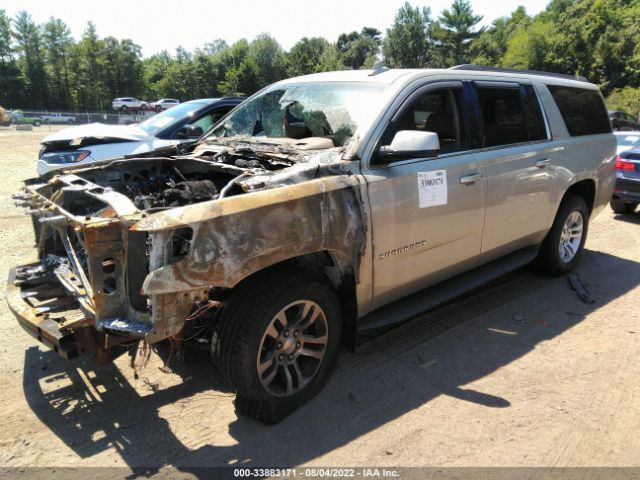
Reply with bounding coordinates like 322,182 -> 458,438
0,125 -> 640,478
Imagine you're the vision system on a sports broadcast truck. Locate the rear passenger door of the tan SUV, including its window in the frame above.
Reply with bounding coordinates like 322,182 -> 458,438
472,81 -> 555,257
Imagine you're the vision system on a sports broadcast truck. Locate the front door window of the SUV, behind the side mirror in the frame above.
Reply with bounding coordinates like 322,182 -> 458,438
384,88 -> 468,153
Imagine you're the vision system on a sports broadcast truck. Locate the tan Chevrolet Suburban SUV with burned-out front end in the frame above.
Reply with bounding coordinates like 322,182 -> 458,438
7,65 -> 616,422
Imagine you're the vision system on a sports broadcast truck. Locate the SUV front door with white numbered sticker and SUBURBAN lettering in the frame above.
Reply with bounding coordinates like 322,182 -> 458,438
361,81 -> 486,309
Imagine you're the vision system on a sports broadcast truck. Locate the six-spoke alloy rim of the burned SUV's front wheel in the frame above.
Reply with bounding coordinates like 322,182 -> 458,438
257,300 -> 329,397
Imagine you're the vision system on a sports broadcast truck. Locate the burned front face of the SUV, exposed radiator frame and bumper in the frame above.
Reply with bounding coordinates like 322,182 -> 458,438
7,169 -> 206,363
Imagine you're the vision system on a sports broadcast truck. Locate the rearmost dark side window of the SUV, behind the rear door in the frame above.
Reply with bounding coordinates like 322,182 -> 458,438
547,85 -> 611,137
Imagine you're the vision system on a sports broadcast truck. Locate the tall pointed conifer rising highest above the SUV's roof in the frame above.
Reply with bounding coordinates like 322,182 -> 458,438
434,0 -> 483,66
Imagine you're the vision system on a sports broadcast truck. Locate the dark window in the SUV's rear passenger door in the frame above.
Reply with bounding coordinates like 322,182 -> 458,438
476,84 -> 547,147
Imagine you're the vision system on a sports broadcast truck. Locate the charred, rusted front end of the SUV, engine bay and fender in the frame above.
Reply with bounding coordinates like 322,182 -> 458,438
9,137 -> 365,361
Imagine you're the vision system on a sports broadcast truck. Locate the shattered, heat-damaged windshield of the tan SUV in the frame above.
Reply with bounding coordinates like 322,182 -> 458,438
210,83 -> 384,147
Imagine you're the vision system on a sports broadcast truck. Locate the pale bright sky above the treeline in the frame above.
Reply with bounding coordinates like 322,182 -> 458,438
0,0 -> 549,56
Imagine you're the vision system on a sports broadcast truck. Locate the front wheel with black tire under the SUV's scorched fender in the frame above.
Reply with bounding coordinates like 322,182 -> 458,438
211,267 -> 342,423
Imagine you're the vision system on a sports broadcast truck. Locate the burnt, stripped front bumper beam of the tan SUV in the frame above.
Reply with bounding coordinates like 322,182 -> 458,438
6,264 -> 100,360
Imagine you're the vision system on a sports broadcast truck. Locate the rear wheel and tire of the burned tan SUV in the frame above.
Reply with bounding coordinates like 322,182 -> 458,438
536,193 -> 589,276
